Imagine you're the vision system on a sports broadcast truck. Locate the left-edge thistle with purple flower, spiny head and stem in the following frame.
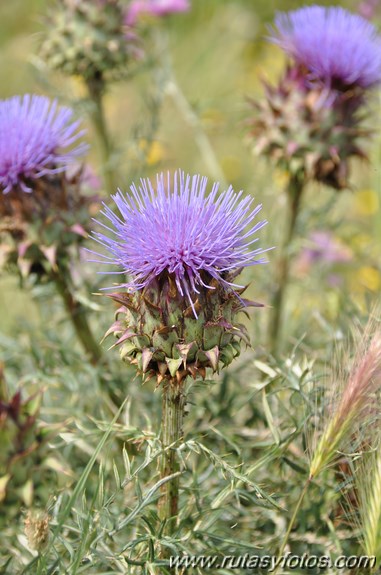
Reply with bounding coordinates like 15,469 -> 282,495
0,95 -> 100,361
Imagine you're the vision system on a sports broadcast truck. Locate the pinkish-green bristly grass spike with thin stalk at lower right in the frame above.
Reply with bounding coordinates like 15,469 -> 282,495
279,321 -> 381,568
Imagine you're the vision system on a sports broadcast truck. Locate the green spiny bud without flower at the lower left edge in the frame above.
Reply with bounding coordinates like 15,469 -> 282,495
0,381 -> 57,524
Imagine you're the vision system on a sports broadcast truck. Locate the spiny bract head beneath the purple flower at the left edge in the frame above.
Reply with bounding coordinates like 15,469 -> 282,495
0,169 -> 98,280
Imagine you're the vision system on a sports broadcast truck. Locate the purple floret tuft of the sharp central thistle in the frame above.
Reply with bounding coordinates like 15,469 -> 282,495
91,171 -> 267,315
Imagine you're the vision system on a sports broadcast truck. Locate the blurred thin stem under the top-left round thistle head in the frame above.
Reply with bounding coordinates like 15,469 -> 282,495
86,75 -> 117,194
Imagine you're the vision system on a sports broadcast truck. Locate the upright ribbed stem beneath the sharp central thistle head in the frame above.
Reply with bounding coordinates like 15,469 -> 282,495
158,378 -> 185,534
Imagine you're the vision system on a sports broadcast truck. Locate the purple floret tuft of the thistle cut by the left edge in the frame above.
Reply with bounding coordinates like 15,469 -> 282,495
0,94 -> 87,194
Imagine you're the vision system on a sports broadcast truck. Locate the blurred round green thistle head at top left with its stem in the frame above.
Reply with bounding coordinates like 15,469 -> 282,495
40,0 -> 136,192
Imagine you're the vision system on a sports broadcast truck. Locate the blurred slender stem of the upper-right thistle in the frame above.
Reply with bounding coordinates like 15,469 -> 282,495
269,174 -> 304,354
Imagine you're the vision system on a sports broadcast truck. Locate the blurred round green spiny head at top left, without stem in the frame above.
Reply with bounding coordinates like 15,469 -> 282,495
40,0 -> 131,81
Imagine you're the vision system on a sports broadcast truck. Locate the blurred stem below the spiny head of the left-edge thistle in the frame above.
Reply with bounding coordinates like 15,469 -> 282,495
51,266 -> 102,364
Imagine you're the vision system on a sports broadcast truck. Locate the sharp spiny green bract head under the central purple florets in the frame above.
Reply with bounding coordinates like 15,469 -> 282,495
105,274 -> 259,383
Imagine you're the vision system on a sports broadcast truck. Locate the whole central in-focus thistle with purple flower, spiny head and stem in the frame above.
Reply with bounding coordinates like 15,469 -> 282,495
89,172 -> 266,529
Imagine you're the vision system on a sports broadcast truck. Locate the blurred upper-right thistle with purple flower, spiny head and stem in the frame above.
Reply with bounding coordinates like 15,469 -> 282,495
248,6 -> 381,352
